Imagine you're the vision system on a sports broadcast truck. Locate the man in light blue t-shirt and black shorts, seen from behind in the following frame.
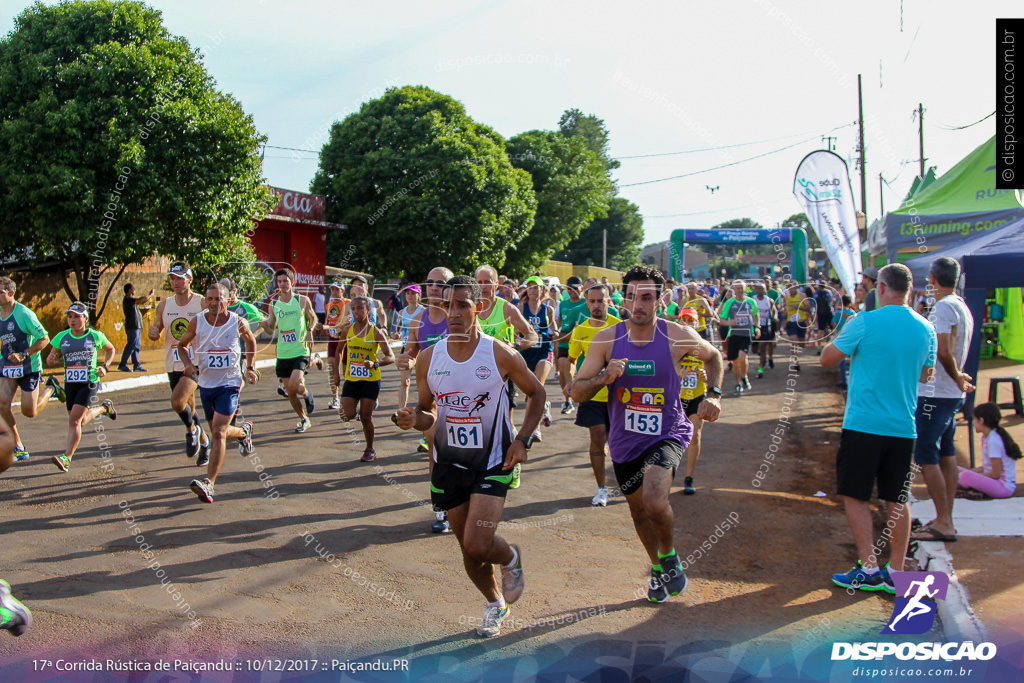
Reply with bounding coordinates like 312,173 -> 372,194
821,263 -> 937,593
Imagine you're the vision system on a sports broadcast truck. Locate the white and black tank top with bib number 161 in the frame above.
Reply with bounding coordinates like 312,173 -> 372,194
427,334 -> 512,472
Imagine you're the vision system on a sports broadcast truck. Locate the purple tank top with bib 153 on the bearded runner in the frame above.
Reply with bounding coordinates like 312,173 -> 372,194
608,319 -> 693,463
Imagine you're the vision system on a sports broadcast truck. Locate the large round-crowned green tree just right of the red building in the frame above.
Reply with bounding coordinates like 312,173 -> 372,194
311,86 -> 537,280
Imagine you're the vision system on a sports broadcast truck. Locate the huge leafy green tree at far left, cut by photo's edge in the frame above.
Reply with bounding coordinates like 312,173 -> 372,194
0,0 -> 274,322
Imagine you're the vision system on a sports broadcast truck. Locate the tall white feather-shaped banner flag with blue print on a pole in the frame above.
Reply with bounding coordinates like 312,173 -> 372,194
793,150 -> 862,295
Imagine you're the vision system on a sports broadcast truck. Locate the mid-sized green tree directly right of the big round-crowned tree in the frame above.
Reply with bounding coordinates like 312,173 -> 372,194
505,130 -> 611,276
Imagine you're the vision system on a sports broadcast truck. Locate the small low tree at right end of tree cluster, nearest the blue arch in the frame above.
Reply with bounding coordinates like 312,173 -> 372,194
555,197 -> 643,270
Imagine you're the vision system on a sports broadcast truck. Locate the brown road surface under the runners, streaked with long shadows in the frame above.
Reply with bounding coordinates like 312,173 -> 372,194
0,347 -> 1007,681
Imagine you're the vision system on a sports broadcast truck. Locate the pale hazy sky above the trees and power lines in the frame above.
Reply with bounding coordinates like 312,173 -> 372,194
0,0 -> 1022,243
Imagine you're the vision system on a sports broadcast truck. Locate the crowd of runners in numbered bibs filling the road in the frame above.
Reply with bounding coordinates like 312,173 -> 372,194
0,262 -> 995,636
